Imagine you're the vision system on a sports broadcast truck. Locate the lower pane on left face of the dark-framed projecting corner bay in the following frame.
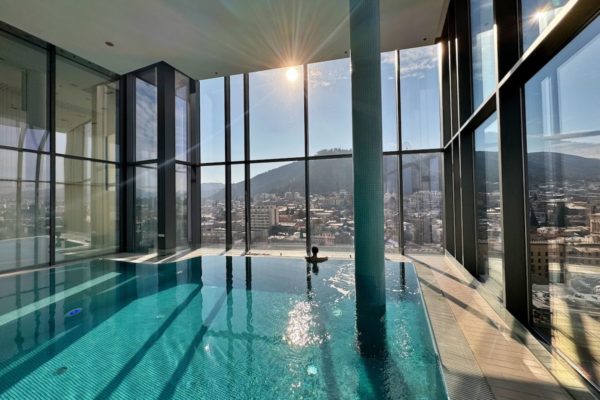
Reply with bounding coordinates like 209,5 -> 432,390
135,164 -> 158,251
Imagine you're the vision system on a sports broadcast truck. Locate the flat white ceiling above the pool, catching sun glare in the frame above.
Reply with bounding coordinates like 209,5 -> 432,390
0,0 -> 448,79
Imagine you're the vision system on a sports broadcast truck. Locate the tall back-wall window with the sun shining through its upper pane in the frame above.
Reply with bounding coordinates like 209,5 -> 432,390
247,66 -> 306,251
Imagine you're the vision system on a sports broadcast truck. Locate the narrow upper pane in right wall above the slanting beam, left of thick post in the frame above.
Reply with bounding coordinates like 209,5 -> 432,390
471,0 -> 501,109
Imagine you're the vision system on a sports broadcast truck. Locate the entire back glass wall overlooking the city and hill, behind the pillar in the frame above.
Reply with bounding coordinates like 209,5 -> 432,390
195,45 -> 443,256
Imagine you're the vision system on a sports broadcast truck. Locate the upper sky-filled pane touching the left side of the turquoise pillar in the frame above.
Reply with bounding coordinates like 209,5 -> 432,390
308,58 -> 352,156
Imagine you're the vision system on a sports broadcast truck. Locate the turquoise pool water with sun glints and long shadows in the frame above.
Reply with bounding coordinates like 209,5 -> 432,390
0,257 -> 447,400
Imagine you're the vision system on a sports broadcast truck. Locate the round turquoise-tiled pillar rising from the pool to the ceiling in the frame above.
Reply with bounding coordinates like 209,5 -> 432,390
350,0 -> 385,332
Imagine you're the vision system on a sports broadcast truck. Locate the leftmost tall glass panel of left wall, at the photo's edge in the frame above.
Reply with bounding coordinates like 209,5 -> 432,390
0,34 -> 50,272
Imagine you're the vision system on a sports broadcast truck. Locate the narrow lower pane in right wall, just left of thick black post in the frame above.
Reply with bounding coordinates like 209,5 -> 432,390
475,114 -> 504,299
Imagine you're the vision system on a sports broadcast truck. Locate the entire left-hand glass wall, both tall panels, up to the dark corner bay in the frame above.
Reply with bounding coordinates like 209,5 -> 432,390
0,28 -> 120,271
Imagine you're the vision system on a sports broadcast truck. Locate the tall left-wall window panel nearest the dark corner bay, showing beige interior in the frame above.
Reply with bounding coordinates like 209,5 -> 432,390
55,56 -> 119,261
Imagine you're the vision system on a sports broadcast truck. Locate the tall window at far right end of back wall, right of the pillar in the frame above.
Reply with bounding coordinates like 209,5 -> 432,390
399,45 -> 443,253
